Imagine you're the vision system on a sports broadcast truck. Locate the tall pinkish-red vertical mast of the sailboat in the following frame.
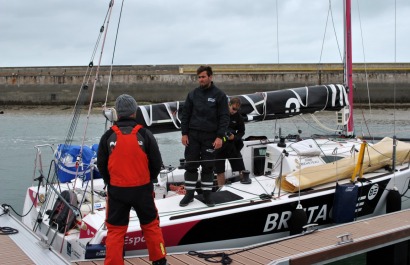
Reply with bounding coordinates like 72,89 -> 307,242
344,0 -> 354,136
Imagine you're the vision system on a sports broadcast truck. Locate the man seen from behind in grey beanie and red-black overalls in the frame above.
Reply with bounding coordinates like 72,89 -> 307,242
97,94 -> 167,265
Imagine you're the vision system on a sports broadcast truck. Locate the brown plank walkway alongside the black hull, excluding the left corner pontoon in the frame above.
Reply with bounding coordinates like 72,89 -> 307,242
75,210 -> 410,265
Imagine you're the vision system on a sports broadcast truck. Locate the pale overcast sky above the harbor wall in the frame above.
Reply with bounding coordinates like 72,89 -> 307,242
0,0 -> 410,67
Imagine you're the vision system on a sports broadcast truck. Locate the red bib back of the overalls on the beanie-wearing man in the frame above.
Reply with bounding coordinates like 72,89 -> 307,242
108,125 -> 150,187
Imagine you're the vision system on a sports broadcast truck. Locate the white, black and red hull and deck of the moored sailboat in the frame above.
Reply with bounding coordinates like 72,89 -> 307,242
23,136 -> 410,261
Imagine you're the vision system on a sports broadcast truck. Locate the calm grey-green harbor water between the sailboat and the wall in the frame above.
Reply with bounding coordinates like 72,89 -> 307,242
0,109 -> 410,212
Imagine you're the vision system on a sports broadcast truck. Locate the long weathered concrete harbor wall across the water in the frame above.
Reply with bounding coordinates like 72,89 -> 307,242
0,63 -> 410,105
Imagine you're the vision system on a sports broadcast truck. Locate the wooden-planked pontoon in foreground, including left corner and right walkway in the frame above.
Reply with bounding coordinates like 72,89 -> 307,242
0,207 -> 410,265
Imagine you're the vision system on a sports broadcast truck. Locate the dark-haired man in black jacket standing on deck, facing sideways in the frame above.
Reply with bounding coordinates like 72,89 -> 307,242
179,66 -> 229,207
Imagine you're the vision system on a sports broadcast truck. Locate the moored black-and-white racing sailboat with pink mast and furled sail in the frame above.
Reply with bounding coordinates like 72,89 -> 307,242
17,0 -> 410,262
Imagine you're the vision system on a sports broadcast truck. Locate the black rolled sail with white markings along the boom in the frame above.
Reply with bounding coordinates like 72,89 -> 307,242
137,84 -> 349,133
